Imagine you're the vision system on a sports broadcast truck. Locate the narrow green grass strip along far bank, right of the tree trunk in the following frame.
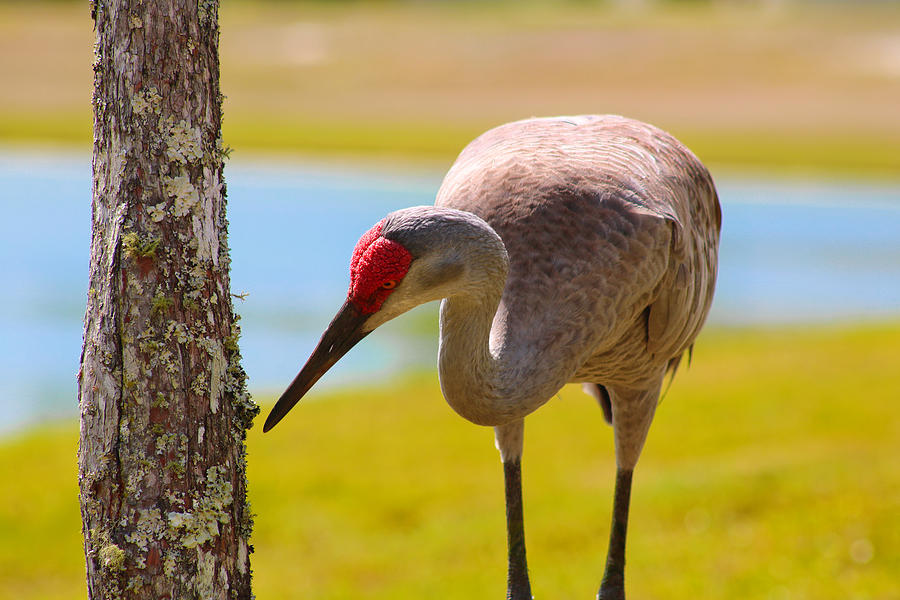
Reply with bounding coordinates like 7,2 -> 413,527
221,119 -> 900,178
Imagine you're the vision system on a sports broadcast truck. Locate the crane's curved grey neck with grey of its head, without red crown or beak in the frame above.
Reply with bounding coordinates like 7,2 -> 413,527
378,206 -> 566,425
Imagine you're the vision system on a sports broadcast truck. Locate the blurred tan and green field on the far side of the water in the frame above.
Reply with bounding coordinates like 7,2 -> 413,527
0,2 -> 900,177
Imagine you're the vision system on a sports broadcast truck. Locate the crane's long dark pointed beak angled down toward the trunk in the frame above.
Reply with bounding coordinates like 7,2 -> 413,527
263,300 -> 370,432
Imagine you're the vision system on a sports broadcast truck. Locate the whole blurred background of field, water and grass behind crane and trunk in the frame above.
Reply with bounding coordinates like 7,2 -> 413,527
0,0 -> 900,600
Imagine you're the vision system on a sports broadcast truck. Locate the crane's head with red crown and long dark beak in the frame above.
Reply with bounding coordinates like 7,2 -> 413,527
263,207 -> 496,431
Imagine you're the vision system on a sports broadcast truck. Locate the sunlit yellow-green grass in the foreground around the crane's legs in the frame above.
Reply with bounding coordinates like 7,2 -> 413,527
0,323 -> 900,600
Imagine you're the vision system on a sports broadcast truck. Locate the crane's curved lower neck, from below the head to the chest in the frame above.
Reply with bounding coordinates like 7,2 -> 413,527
438,269 -> 564,425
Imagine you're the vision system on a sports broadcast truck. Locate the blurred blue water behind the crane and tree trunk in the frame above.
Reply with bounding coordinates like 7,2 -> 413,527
0,151 -> 900,431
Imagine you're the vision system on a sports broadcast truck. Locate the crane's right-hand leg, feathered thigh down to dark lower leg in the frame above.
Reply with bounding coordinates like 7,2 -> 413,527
597,384 -> 662,600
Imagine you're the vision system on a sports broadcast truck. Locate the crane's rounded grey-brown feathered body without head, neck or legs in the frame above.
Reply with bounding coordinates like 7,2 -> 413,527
435,116 -> 721,402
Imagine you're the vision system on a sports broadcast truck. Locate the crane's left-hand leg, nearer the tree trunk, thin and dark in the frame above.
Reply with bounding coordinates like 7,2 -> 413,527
494,419 -> 531,600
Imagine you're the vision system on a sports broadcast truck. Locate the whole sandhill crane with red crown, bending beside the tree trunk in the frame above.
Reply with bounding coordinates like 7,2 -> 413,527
263,115 -> 721,600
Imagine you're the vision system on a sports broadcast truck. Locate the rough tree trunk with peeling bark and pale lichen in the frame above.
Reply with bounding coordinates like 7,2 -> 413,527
78,0 -> 258,599
